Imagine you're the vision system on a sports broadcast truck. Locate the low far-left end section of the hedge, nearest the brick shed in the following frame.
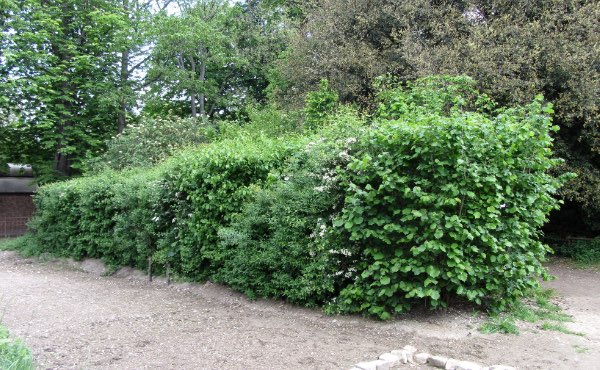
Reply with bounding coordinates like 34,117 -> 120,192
26,163 -> 169,267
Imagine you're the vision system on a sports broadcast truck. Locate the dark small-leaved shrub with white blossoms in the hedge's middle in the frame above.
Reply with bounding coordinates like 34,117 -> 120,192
215,112 -> 364,305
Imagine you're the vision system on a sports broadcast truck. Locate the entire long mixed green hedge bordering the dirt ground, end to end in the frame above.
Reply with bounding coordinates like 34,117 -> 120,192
19,77 -> 568,319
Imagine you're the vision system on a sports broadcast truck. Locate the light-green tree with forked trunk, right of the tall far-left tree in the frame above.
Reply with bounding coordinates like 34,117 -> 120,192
147,0 -> 243,118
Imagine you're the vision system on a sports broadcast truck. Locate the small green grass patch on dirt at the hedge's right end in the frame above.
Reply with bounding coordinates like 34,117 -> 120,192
479,289 -> 583,335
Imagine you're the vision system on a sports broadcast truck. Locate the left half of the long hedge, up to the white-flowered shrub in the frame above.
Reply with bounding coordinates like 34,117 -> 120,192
27,136 -> 294,278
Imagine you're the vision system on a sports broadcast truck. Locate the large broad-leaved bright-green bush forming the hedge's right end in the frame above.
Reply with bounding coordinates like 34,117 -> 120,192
334,80 -> 565,318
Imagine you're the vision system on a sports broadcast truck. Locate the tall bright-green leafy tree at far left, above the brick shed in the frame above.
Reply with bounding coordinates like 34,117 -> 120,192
0,0 -> 124,175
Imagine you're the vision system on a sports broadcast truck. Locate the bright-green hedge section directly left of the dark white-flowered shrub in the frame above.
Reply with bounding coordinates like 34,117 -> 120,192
156,136 -> 297,279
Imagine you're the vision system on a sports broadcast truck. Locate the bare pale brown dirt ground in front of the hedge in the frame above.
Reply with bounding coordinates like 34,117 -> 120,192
0,251 -> 600,369
